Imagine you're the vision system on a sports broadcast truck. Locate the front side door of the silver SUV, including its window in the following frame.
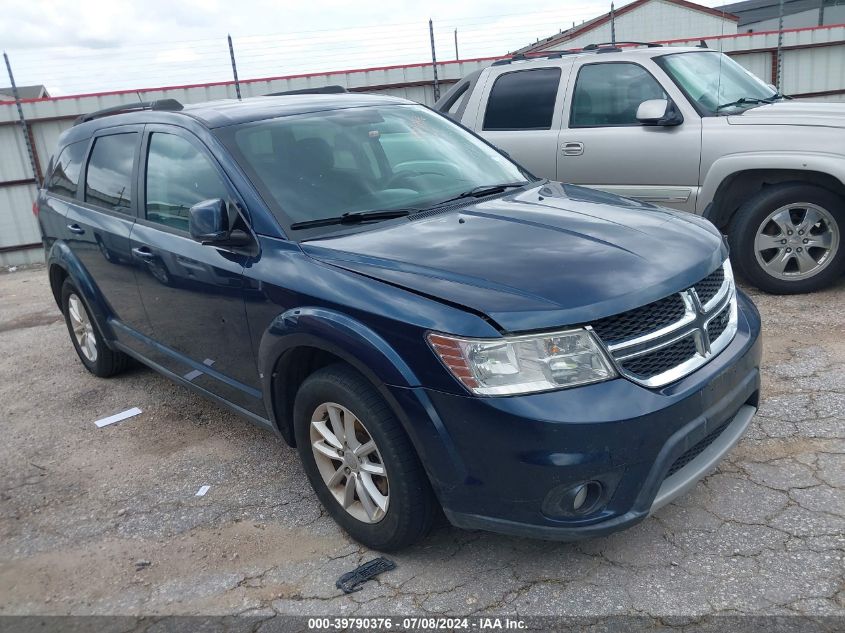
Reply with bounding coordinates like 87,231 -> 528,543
557,61 -> 701,211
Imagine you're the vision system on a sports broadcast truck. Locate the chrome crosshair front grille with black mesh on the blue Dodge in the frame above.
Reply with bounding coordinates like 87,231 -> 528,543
592,263 -> 736,387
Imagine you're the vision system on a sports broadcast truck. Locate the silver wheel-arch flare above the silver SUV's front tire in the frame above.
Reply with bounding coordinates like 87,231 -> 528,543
696,151 -> 845,215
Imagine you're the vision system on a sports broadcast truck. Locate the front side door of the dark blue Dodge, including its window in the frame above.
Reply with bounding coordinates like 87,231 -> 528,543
131,125 -> 266,415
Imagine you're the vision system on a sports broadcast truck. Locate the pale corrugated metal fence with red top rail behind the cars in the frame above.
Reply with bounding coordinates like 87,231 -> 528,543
0,25 -> 845,266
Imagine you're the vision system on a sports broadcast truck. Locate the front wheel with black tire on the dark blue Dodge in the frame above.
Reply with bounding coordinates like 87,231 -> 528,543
294,364 -> 438,551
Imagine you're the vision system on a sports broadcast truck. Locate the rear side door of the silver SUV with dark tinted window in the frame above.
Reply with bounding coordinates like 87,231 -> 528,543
474,64 -> 571,179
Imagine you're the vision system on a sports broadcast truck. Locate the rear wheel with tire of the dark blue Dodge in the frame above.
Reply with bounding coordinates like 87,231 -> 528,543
62,279 -> 129,378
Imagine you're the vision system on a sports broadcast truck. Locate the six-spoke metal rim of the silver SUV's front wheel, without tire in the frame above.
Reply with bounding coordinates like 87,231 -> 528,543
754,202 -> 839,281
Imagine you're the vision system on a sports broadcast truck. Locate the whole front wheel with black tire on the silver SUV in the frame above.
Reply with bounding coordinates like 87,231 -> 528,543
728,183 -> 845,294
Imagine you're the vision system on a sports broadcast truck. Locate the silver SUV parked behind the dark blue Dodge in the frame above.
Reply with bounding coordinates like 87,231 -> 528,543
442,44 -> 845,294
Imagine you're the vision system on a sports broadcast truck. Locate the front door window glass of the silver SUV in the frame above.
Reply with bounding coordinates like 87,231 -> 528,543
569,63 -> 669,127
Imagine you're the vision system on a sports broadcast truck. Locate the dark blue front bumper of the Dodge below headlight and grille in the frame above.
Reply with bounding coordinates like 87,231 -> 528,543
391,293 -> 761,540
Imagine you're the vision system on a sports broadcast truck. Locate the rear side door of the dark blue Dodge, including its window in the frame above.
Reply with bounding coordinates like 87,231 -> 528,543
63,126 -> 149,348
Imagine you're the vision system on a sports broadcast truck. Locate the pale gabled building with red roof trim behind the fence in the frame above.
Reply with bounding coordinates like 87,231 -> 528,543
516,0 -> 739,53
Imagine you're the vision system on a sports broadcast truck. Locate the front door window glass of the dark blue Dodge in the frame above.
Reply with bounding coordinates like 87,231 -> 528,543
145,132 -> 229,231
